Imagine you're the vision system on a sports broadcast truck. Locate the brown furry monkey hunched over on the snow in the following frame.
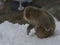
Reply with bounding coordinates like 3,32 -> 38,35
24,6 -> 55,38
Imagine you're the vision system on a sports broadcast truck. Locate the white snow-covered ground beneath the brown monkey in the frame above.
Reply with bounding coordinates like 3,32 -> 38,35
0,18 -> 60,45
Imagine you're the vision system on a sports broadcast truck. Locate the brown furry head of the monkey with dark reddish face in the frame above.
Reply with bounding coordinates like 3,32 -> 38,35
24,6 -> 43,22
